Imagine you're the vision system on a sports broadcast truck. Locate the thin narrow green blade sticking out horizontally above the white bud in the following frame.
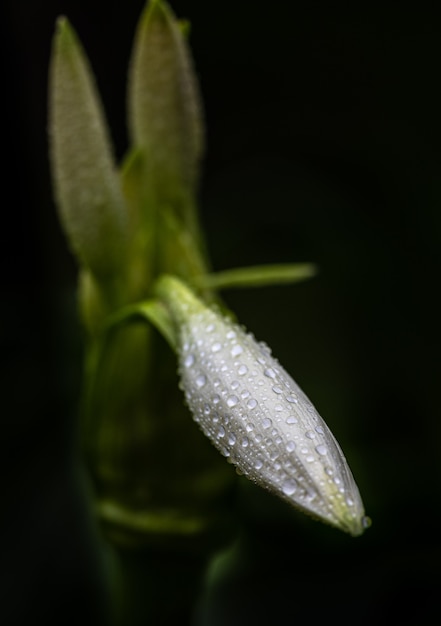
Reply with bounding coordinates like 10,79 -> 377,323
191,263 -> 317,289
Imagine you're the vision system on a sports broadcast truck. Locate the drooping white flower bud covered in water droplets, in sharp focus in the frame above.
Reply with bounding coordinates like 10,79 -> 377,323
159,277 -> 368,536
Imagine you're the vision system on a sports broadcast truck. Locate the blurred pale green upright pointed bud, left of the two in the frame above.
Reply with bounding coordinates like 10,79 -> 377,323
49,18 -> 128,281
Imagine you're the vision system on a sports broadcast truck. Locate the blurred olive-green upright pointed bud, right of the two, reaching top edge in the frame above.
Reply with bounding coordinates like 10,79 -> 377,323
128,0 -> 203,208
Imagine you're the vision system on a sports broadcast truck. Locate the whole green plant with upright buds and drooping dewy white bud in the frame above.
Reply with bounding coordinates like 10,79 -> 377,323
49,0 -> 366,620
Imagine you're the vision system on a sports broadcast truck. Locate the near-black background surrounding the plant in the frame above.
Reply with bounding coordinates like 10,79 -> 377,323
0,0 -> 441,626
